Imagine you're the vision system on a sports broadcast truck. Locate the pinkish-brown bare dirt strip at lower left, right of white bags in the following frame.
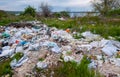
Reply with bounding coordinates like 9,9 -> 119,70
13,50 -> 47,77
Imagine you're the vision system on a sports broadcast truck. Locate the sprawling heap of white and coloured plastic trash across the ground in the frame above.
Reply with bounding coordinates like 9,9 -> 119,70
0,21 -> 120,77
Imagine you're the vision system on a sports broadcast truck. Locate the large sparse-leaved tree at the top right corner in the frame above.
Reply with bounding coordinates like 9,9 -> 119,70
92,0 -> 120,15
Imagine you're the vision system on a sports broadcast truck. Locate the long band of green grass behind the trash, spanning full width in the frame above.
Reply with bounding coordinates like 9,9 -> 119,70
0,16 -> 120,41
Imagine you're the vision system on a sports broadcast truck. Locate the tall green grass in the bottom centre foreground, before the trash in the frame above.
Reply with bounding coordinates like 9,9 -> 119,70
37,57 -> 102,77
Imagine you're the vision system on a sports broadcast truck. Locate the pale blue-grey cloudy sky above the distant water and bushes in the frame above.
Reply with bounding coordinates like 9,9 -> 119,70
0,0 -> 92,11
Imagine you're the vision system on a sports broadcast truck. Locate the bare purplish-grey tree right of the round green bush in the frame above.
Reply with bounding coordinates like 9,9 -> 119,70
39,2 -> 52,17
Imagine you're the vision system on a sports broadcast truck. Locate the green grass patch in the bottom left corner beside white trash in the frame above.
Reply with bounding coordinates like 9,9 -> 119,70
0,52 -> 23,77
